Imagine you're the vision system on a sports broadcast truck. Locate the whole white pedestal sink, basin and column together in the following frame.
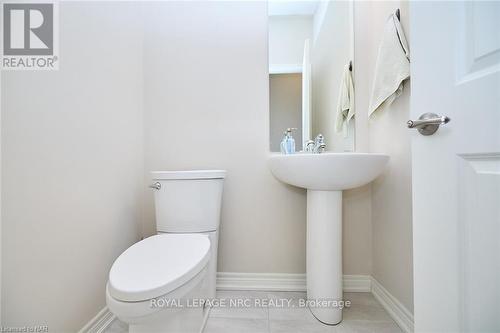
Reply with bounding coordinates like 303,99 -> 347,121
269,153 -> 389,325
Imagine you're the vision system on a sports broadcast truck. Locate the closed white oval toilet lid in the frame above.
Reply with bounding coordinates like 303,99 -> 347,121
108,234 -> 210,302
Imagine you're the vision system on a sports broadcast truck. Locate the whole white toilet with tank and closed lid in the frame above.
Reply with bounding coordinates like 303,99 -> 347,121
106,170 -> 226,333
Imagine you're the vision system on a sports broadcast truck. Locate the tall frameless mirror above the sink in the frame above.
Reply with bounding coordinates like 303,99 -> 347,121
268,0 -> 355,152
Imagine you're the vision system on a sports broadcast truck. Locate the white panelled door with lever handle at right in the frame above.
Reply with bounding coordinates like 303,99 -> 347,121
409,1 -> 500,332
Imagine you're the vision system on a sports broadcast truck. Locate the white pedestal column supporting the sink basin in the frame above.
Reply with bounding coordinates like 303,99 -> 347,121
307,190 -> 343,325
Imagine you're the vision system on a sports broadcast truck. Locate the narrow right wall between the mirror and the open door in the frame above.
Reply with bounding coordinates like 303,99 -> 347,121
354,1 -> 413,311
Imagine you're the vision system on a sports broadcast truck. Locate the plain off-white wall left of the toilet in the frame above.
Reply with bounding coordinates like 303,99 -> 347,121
1,2 -> 143,332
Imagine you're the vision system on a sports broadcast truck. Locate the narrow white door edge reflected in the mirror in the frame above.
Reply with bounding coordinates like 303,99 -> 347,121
300,39 -> 311,149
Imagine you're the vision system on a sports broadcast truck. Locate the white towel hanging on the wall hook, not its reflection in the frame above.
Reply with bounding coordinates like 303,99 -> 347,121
368,14 -> 410,116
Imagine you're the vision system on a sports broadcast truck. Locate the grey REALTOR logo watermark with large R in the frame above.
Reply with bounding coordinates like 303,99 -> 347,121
1,1 -> 59,70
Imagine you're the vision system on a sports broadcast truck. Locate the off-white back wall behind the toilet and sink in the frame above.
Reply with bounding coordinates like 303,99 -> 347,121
144,2 -> 306,273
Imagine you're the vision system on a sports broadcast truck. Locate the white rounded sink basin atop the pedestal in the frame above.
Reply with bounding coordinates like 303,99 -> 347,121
269,153 -> 389,191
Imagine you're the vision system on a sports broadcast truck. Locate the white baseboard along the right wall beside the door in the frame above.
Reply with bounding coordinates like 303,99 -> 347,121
372,278 -> 414,333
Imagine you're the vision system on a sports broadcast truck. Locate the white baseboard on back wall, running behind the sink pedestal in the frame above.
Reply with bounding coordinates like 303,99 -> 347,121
217,272 -> 371,292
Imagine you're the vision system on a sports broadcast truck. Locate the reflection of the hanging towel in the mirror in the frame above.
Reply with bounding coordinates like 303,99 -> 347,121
335,65 -> 354,137
